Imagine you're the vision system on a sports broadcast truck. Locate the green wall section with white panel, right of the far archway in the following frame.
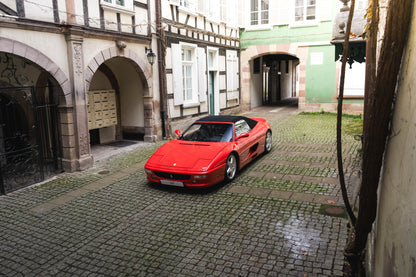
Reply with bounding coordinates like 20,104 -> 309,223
306,45 -> 336,103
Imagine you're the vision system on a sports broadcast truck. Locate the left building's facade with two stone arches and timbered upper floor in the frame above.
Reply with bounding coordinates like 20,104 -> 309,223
0,0 -> 156,193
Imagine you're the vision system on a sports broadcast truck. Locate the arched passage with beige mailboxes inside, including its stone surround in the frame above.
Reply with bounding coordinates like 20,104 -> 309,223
86,48 -> 155,144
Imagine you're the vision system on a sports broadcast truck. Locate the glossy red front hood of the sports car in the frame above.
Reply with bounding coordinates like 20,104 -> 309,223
146,140 -> 229,171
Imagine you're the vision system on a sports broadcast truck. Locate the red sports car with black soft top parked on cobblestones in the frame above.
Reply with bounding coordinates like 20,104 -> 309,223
144,116 -> 272,187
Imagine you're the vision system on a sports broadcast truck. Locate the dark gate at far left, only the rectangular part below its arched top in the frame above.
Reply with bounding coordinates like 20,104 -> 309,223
0,84 -> 62,194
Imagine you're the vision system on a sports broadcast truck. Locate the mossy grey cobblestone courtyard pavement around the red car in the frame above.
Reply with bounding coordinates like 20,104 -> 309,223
0,104 -> 360,277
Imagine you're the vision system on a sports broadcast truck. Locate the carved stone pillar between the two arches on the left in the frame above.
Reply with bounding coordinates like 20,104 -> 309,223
66,28 -> 93,170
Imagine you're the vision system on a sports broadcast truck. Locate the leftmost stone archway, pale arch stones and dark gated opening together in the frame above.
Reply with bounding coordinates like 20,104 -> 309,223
0,38 -> 73,193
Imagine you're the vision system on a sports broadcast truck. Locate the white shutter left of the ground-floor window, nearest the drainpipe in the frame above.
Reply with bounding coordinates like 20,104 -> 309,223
172,43 -> 183,106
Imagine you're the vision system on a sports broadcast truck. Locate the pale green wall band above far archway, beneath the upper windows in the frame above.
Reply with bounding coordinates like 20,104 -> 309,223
240,21 -> 335,51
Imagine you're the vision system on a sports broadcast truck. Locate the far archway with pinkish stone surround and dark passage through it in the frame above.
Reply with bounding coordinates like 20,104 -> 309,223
241,44 -> 307,109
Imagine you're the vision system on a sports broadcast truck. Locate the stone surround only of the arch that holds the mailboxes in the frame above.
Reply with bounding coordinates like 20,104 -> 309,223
85,47 -> 156,141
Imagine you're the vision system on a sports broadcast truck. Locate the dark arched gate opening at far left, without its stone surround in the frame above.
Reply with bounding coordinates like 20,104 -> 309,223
0,52 -> 62,194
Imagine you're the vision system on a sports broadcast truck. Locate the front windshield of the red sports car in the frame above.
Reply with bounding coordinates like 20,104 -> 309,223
179,123 -> 233,142
